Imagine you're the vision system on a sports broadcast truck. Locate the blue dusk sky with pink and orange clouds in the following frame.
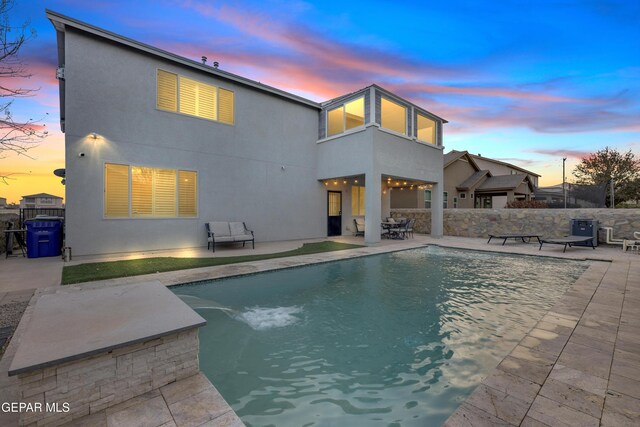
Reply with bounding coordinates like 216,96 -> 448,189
0,0 -> 640,202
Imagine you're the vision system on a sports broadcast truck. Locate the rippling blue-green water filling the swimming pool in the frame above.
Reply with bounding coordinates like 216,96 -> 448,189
173,247 -> 586,427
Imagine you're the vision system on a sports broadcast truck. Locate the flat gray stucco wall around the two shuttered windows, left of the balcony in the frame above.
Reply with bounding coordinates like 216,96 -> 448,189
65,28 -> 326,255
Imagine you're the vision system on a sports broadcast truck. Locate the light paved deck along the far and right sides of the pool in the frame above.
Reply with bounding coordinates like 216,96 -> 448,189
0,236 -> 640,426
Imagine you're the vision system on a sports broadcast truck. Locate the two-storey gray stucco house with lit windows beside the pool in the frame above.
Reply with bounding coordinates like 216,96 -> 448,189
47,11 -> 446,255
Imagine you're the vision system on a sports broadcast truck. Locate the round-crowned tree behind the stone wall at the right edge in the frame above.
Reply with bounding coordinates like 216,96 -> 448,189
573,147 -> 640,204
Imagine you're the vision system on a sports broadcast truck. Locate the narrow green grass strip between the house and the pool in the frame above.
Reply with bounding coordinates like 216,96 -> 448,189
62,242 -> 363,285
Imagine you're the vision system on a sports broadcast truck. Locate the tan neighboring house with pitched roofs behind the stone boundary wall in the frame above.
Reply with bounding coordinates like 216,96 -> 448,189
391,150 -> 540,209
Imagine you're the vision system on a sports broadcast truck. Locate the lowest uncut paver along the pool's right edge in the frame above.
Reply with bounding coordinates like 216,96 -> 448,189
466,384 -> 531,425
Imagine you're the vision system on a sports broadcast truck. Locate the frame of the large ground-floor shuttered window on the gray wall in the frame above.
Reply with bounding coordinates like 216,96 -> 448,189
102,161 -> 200,221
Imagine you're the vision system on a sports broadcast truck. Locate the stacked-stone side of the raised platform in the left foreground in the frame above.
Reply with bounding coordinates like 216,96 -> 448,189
18,328 -> 199,427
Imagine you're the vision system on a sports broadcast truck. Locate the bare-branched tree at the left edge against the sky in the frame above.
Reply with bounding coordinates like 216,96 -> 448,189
0,0 -> 47,183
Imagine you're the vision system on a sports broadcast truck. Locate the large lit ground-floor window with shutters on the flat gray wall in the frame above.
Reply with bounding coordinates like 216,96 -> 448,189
104,163 -> 198,218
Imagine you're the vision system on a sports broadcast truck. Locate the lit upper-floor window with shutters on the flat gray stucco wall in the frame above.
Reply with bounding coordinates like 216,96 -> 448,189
156,70 -> 234,125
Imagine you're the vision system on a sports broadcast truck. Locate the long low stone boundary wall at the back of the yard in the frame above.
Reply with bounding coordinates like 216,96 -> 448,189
391,209 -> 640,242
